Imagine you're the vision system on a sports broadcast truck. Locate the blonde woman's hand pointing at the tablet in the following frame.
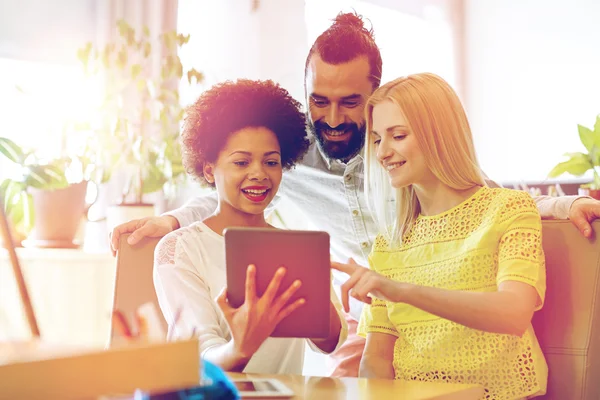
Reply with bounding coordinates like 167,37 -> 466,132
331,259 -> 402,312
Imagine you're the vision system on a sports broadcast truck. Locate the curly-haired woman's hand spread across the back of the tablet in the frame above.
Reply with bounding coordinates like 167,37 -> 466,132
217,265 -> 305,359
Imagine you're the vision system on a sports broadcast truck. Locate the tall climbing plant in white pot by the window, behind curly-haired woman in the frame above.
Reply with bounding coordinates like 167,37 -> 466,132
77,20 -> 203,228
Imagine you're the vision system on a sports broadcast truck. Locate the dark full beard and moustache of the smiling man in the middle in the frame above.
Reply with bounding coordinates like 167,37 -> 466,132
307,117 -> 366,162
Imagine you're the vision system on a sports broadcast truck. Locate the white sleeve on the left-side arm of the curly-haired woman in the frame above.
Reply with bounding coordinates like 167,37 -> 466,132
153,231 -> 229,356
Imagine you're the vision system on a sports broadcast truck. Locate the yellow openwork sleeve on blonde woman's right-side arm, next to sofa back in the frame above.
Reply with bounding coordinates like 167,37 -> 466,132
496,191 -> 546,310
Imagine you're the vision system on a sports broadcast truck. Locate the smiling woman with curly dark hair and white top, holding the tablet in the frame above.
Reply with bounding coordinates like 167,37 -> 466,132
154,80 -> 346,374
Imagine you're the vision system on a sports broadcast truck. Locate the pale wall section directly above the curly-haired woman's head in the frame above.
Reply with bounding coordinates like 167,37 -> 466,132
178,0 -> 308,106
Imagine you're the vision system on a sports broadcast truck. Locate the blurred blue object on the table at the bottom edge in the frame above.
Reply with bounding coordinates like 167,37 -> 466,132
134,360 -> 240,400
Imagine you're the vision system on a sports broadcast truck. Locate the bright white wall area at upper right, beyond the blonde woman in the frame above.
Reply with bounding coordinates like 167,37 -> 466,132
465,0 -> 600,181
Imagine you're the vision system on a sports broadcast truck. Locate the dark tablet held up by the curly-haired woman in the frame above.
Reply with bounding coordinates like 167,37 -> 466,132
223,228 -> 331,339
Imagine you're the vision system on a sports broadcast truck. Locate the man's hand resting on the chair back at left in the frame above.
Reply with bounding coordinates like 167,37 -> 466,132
109,215 -> 179,256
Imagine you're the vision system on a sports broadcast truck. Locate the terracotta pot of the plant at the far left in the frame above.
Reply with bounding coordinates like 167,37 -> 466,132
23,181 -> 91,248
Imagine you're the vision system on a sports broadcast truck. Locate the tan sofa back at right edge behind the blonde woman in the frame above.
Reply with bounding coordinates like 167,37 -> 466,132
533,221 -> 600,400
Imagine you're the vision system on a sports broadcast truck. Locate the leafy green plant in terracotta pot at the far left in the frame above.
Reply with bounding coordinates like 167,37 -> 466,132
0,137 -> 91,248
